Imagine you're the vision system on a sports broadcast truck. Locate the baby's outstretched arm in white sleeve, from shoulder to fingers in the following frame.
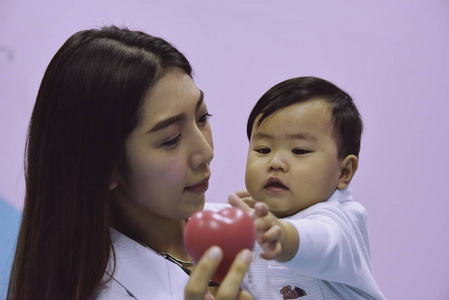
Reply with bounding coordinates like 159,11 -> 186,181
229,193 -> 374,286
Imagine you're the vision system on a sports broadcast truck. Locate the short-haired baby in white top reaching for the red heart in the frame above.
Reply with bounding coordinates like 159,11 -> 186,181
229,77 -> 385,300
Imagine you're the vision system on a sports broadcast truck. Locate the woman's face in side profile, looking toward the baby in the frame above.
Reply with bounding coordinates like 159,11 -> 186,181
115,69 -> 214,220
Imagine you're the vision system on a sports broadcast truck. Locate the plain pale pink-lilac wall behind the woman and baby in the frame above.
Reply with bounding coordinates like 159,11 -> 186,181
0,0 -> 449,299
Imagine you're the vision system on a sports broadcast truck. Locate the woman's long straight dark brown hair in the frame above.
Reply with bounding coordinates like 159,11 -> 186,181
7,26 -> 192,300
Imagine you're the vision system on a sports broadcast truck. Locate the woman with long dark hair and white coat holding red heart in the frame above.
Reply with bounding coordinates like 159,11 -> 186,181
7,26 -> 250,299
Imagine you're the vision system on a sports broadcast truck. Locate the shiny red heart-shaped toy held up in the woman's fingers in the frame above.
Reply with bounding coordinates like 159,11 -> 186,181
184,207 -> 256,282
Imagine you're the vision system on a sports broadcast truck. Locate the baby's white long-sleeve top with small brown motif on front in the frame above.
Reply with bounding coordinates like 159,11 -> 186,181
245,189 -> 385,300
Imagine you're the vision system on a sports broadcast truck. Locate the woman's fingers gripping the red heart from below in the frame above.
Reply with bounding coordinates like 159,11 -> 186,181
184,246 -> 253,300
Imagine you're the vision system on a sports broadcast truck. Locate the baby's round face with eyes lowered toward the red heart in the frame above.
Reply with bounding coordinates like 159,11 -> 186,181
245,100 -> 341,217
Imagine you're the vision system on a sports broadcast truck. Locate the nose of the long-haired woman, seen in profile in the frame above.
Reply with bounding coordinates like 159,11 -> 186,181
190,129 -> 214,168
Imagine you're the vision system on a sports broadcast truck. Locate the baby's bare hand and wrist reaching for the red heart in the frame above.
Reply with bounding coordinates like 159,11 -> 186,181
228,191 -> 299,262
